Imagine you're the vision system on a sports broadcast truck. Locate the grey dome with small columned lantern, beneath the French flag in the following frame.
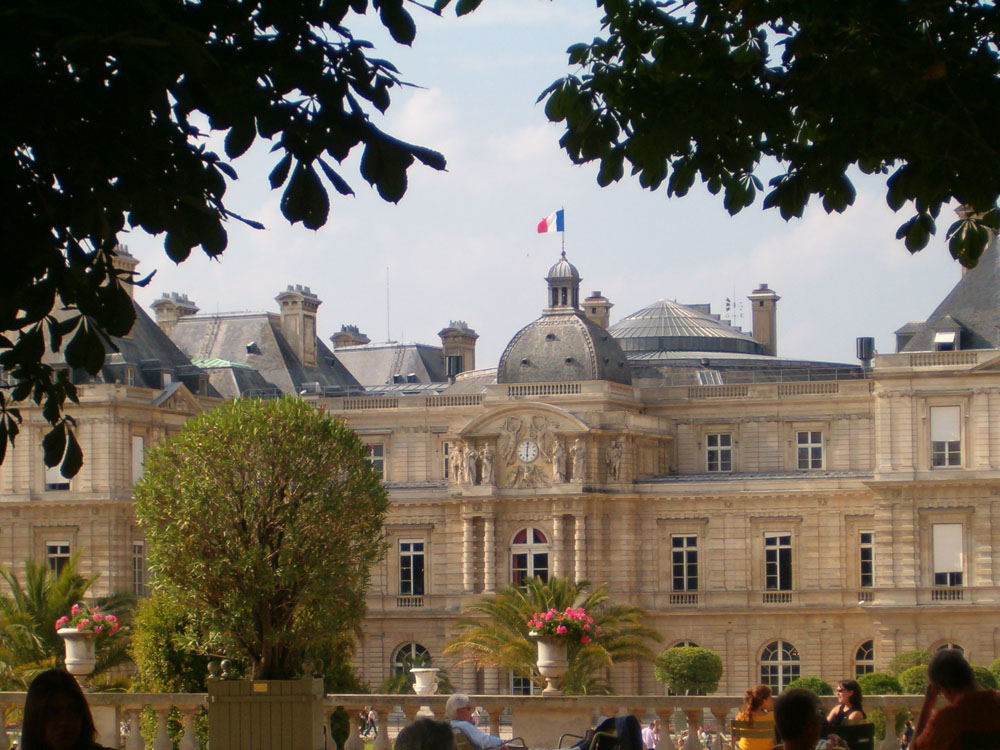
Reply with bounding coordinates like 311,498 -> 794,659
497,251 -> 632,385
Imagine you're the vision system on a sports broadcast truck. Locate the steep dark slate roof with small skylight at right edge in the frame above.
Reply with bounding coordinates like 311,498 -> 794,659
897,237 -> 1000,352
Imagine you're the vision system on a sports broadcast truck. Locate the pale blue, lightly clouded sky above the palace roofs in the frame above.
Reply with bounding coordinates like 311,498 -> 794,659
124,0 -> 960,368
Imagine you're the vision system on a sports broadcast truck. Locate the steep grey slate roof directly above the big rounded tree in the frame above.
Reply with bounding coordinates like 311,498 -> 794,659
170,312 -> 361,394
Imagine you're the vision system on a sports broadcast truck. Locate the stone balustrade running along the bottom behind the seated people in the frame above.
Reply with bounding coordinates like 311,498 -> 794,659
0,693 -> 923,750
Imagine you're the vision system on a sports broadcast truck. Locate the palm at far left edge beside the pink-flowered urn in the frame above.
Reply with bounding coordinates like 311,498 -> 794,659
0,554 -> 134,689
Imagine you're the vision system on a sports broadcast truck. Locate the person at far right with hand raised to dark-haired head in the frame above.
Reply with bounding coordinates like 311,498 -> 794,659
910,648 -> 1000,750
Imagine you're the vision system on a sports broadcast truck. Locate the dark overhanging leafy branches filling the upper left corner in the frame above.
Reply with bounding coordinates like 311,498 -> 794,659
0,0 -> 479,477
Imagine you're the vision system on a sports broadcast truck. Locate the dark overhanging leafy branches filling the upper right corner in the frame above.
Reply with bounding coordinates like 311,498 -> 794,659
540,0 -> 1000,267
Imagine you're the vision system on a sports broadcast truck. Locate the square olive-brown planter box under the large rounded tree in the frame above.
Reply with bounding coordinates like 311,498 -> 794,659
208,677 -> 323,750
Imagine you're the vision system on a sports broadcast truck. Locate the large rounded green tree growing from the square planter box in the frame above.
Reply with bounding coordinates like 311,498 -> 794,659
135,397 -> 388,679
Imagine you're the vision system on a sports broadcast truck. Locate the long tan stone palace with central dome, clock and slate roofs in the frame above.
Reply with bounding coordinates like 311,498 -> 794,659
0,240 -> 1000,695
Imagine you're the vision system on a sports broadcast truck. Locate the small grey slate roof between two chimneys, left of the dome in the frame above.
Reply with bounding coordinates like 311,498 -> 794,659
335,342 -> 448,387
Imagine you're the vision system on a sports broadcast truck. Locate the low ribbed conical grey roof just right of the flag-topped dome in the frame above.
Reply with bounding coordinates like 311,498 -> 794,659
608,300 -> 764,359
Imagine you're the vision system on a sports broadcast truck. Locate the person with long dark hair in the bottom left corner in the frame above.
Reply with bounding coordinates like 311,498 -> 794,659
20,669 -> 110,750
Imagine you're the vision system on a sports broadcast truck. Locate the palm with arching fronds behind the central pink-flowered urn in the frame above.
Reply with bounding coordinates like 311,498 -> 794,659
444,578 -> 662,695
